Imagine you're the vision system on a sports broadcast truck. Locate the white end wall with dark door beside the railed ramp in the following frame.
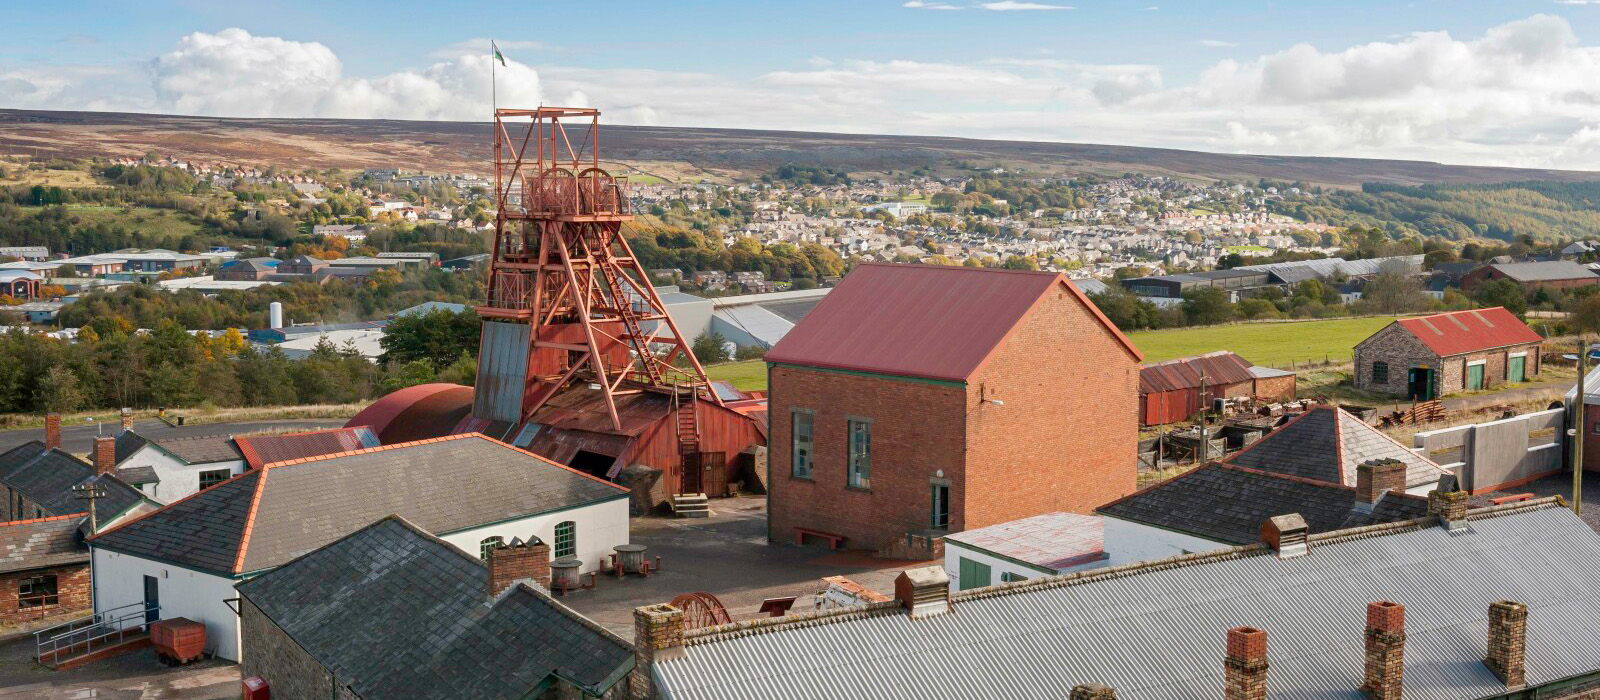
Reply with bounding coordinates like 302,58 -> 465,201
93,548 -> 242,662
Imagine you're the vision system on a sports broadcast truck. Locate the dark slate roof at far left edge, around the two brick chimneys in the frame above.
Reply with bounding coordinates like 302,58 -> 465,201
0,439 -> 144,521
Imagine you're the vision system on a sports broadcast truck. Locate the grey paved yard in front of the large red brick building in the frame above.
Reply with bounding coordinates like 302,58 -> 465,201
563,497 -> 928,639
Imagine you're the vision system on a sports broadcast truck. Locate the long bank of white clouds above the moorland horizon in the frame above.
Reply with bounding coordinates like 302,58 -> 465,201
15,14 -> 1600,169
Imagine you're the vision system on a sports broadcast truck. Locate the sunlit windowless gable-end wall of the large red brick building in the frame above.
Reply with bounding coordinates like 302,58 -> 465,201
958,288 -> 1139,527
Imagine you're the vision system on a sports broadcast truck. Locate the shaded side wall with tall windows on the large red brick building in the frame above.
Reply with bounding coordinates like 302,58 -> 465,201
766,366 -> 966,550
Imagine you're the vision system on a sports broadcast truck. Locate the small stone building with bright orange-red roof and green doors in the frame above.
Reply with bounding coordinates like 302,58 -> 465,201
1355,307 -> 1544,400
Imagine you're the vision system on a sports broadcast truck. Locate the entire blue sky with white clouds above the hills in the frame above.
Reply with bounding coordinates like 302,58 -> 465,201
9,0 -> 1600,168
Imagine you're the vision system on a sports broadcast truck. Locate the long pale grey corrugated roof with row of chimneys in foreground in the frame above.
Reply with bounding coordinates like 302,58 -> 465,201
654,500 -> 1600,700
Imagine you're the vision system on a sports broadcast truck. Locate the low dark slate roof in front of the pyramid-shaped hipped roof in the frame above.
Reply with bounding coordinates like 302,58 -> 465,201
1096,463 -> 1427,545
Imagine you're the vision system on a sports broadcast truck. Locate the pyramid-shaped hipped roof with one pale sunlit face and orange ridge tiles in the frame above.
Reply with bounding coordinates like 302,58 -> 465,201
1222,406 -> 1450,487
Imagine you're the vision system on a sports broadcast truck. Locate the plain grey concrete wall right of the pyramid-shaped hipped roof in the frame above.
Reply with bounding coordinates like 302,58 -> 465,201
1413,409 -> 1566,492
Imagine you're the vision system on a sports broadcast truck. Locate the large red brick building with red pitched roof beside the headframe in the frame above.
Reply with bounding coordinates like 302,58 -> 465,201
766,264 -> 1141,550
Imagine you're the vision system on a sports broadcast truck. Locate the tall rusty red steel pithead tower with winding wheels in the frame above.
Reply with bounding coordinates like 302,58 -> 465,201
474,107 -> 722,437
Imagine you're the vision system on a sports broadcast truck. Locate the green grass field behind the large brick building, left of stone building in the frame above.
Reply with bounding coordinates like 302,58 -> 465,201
1128,316 -> 1395,366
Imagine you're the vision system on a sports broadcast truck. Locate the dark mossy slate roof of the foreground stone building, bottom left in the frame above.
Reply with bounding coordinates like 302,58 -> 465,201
238,516 -> 634,700
